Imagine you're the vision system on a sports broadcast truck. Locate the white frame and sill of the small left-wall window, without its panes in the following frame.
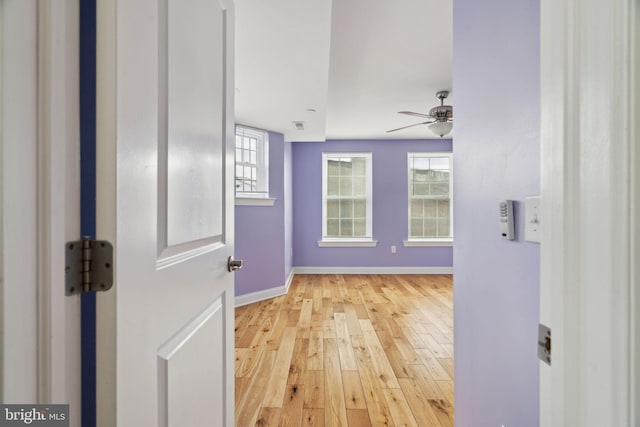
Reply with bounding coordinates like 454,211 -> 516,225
233,125 -> 275,206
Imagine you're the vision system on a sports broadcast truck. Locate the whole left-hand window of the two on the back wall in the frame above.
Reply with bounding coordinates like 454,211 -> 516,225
318,153 -> 376,246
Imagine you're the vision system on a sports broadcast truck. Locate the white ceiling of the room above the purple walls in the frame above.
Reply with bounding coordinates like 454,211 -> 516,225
235,0 -> 454,141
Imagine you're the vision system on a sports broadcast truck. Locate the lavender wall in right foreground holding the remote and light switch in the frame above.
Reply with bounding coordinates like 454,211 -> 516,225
453,0 -> 540,427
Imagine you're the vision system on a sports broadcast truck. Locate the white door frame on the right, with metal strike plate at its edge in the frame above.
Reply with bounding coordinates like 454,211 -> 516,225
540,0 -> 640,427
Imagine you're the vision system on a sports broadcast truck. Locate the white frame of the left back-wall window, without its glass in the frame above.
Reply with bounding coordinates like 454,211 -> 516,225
318,152 -> 377,247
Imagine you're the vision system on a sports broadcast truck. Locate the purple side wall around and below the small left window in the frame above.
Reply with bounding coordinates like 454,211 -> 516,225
235,132 -> 290,296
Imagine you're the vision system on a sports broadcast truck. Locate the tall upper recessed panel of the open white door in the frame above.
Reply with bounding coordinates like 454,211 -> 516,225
164,0 -> 224,246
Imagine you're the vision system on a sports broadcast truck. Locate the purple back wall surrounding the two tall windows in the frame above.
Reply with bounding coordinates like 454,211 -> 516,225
293,139 -> 456,267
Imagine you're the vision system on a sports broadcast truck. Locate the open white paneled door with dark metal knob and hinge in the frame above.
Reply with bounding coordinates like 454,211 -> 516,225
97,0 -> 234,427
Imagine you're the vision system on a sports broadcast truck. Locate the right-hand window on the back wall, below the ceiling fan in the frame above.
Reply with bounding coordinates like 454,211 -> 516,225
405,153 -> 453,246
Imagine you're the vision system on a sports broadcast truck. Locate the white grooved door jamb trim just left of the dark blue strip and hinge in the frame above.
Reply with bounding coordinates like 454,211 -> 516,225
38,0 -> 81,410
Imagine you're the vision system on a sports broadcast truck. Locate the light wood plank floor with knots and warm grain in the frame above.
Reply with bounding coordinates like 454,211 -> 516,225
235,275 -> 453,427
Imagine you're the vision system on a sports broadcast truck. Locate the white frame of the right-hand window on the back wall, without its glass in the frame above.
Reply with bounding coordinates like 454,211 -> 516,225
403,152 -> 454,247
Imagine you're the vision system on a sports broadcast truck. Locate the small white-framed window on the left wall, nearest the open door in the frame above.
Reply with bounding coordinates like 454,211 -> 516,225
236,126 -> 273,204
